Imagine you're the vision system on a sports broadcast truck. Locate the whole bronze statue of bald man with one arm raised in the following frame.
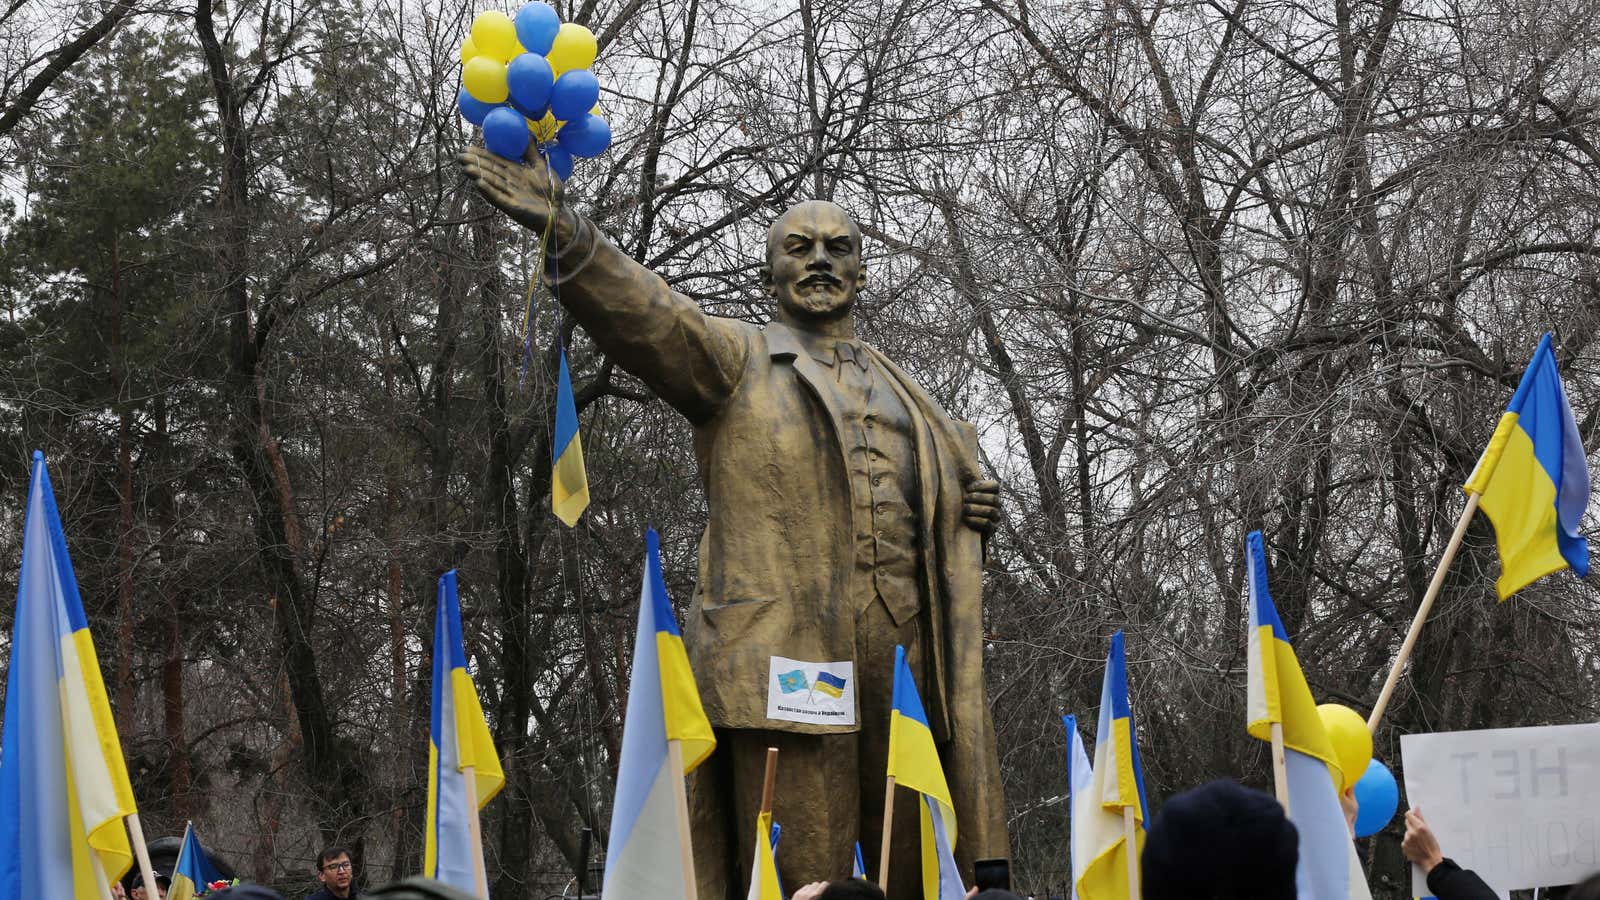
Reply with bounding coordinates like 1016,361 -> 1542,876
459,147 -> 1010,900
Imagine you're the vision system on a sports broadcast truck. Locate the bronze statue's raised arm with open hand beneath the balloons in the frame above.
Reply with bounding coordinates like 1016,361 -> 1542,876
456,147 -> 749,423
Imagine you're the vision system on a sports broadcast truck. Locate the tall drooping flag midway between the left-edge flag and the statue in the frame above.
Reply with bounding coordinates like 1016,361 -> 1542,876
422,569 -> 506,894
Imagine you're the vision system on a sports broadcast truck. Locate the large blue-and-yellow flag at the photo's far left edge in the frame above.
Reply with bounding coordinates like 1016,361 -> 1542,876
0,450 -> 138,900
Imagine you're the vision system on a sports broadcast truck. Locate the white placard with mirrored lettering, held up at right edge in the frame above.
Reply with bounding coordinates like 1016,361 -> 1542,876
1400,714 -> 1600,897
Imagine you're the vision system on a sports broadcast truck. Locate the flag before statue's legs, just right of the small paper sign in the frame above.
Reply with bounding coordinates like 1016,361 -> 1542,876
880,647 -> 966,900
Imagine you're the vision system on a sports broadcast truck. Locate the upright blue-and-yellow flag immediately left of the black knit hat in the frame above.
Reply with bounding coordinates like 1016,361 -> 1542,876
1072,631 -> 1149,900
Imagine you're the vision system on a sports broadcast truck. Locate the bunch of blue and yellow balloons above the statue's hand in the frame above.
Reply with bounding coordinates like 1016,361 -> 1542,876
456,0 -> 611,181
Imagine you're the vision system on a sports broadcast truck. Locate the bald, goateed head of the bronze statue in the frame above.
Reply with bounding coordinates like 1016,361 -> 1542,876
762,200 -> 867,320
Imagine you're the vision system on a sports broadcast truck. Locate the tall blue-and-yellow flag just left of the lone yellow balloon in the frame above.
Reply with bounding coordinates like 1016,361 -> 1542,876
1245,532 -> 1371,900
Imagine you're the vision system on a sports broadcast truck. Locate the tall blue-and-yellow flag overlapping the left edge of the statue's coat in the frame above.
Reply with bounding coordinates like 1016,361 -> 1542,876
602,528 -> 717,900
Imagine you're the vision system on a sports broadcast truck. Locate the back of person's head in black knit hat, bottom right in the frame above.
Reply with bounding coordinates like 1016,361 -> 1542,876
1141,780 -> 1299,900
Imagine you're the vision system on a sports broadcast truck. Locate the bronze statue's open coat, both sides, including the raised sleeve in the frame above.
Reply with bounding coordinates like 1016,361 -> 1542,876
552,219 -> 1010,863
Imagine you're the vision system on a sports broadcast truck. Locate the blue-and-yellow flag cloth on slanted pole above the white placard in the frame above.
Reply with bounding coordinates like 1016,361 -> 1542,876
1464,335 -> 1589,601
